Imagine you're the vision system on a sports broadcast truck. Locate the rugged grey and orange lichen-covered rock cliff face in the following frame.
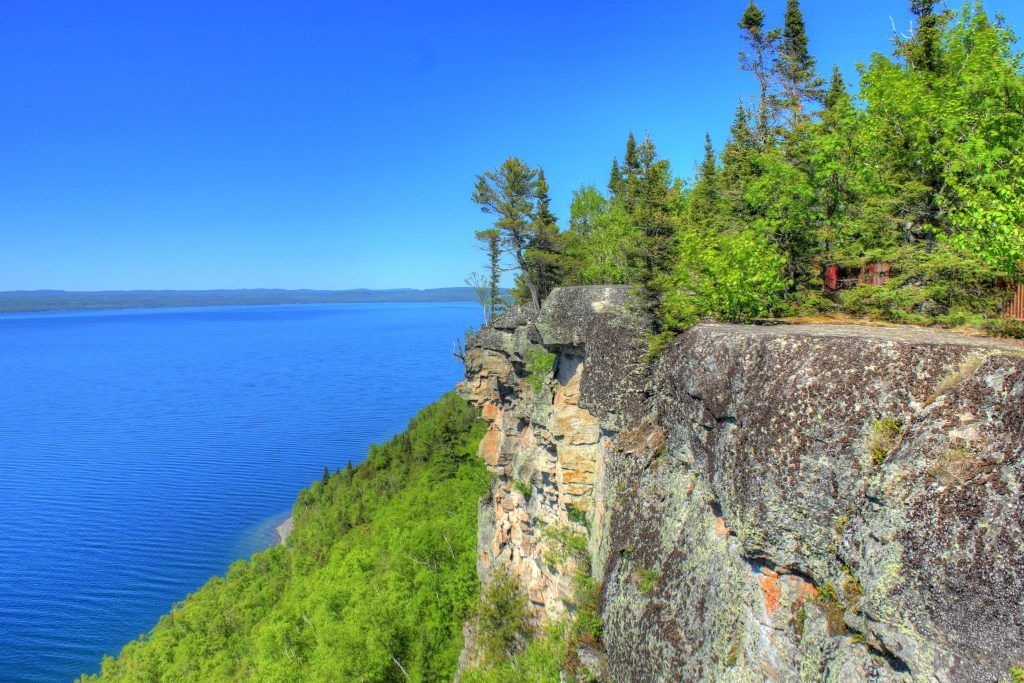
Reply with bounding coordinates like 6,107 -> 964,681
460,287 -> 1024,681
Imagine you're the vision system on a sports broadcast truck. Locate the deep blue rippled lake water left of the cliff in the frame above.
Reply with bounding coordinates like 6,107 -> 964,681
0,303 -> 480,681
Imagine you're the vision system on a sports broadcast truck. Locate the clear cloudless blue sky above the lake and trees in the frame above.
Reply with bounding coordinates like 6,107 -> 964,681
0,0 -> 1024,290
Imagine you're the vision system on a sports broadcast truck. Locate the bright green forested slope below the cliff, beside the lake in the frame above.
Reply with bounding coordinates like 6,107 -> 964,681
83,394 -> 488,681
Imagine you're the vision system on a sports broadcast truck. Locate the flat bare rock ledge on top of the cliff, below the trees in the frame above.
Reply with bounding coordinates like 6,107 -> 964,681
695,323 -> 1024,352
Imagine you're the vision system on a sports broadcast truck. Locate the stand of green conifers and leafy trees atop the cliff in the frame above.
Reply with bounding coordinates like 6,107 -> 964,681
473,0 -> 1024,347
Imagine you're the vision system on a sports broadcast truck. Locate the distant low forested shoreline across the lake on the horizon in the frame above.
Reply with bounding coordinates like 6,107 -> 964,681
0,287 -> 477,313
